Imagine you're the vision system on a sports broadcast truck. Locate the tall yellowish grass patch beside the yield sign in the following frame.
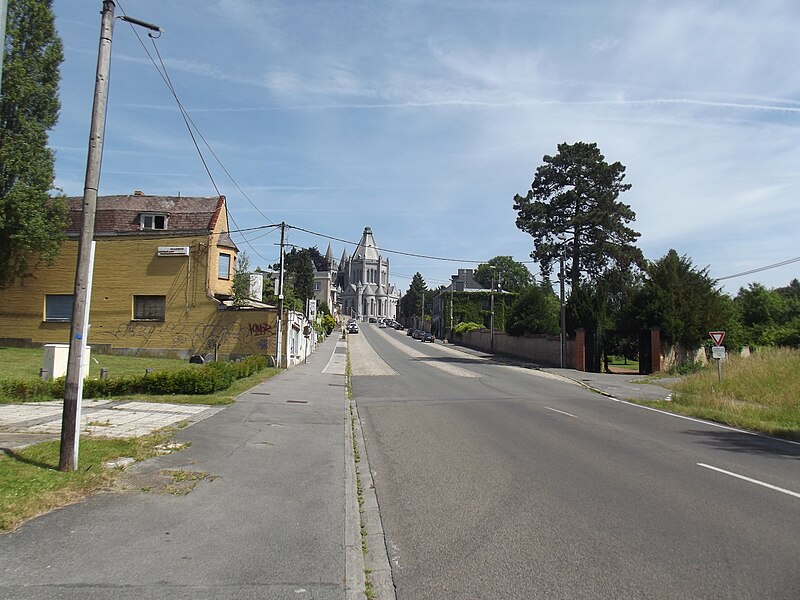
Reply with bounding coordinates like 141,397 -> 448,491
644,348 -> 800,440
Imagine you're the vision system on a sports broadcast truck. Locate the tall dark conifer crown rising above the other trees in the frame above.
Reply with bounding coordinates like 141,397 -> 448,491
514,142 -> 644,288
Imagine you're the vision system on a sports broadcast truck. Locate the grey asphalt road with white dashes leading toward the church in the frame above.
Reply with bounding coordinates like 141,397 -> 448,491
351,324 -> 800,600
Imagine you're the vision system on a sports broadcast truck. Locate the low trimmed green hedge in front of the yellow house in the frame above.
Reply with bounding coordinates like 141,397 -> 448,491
0,356 -> 267,400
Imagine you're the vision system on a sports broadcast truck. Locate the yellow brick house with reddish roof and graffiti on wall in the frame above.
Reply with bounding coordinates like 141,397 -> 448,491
0,192 -> 276,358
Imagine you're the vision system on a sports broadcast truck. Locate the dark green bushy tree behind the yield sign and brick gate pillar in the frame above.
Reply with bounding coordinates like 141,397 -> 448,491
633,250 -> 735,350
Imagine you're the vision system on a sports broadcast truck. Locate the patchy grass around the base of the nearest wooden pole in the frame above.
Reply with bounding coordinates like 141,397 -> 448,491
0,430 -> 171,531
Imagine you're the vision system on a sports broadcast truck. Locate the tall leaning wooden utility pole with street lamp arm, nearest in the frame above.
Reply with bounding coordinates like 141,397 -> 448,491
58,0 -> 160,471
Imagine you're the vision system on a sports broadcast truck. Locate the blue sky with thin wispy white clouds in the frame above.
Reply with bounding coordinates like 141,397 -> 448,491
50,0 -> 800,294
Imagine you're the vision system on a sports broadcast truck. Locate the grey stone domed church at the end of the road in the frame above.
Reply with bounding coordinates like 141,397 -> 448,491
325,227 -> 400,320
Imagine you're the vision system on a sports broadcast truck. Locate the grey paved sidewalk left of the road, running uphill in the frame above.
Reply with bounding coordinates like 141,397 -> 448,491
0,336 -> 363,600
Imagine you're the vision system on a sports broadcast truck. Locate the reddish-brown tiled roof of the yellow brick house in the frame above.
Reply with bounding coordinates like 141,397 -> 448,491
67,195 -> 225,233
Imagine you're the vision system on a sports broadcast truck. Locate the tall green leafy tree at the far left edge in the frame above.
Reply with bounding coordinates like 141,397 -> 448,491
0,0 -> 67,286
